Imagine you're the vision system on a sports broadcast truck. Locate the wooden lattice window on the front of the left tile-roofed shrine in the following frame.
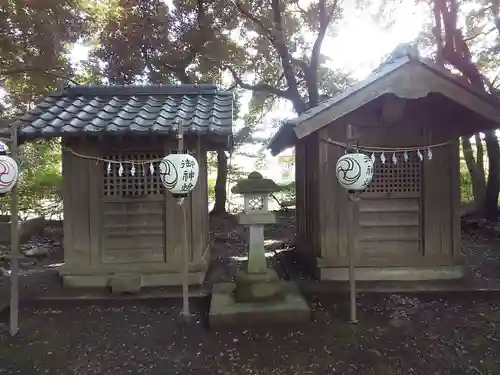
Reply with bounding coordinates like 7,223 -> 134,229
103,152 -> 163,196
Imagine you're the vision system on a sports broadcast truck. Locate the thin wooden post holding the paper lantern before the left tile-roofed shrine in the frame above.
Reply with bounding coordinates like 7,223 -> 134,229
177,122 -> 191,323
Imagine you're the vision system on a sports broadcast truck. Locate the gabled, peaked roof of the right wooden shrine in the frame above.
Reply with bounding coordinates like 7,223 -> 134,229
268,56 -> 500,155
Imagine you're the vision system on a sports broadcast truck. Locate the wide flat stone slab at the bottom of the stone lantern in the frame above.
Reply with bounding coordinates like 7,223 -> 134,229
209,282 -> 311,327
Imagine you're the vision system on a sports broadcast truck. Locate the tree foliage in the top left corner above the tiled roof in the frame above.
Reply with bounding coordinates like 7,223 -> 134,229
0,0 -> 91,112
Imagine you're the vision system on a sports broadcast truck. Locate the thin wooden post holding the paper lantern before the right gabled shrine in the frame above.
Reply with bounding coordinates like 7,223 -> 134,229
346,124 -> 359,324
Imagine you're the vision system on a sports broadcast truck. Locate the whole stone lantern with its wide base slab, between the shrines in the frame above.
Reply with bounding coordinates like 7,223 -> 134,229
210,172 -> 310,325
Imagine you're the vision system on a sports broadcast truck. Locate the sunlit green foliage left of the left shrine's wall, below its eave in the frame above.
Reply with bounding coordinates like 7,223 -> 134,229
0,141 -> 62,217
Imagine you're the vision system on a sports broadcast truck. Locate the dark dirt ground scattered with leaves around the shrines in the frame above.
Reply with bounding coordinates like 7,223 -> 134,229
0,215 -> 500,375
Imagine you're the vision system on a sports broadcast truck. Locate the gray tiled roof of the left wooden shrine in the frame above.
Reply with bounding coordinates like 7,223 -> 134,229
11,85 -> 233,138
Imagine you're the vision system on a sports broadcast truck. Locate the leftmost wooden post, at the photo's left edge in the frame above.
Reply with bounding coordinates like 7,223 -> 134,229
10,125 -> 20,336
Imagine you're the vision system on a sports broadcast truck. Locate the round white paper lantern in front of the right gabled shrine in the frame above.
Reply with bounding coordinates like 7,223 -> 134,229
335,153 -> 374,191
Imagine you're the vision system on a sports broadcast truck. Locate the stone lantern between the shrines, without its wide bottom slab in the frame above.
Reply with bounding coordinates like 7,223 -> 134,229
232,172 -> 281,302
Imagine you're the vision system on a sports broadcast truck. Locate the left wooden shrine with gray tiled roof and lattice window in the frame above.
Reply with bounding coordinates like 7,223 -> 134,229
11,85 -> 233,287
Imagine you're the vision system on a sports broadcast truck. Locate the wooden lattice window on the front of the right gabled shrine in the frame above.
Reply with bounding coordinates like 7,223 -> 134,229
365,155 -> 422,193
